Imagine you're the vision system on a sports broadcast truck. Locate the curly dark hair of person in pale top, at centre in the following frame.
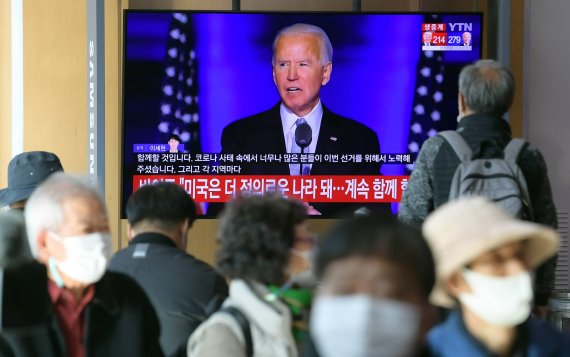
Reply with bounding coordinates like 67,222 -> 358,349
217,194 -> 307,284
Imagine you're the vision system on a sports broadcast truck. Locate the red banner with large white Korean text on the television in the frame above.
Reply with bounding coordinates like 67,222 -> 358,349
133,175 -> 409,202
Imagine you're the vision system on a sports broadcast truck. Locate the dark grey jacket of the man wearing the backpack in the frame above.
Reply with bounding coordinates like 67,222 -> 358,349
398,114 -> 557,305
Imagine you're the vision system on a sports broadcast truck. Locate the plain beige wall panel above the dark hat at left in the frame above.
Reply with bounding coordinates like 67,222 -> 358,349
24,0 -> 87,173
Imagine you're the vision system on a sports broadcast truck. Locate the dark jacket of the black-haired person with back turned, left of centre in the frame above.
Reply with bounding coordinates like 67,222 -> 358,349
109,233 -> 228,356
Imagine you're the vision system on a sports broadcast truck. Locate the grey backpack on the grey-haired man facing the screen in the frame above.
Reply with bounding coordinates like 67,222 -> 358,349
439,130 -> 533,220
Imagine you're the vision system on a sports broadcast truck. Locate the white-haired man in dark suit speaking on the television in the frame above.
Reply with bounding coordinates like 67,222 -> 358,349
217,24 -> 380,214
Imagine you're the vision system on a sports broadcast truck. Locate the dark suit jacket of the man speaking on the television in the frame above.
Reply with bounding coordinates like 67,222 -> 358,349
213,103 -> 385,216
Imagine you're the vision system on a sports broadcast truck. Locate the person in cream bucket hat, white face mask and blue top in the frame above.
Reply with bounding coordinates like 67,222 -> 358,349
423,197 -> 570,357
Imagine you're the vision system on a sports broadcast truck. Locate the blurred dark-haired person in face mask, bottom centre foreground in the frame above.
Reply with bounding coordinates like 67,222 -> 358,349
302,216 -> 435,357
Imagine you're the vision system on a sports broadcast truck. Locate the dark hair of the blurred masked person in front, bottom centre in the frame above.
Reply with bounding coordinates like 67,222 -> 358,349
316,216 -> 435,298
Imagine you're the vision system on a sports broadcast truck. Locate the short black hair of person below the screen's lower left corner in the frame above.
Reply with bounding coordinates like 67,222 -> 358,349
126,182 -> 196,230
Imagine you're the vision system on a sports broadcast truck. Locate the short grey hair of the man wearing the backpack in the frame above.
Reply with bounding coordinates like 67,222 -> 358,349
459,59 -> 515,117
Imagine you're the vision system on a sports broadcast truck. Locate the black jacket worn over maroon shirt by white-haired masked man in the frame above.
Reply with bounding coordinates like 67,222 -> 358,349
0,263 -> 163,357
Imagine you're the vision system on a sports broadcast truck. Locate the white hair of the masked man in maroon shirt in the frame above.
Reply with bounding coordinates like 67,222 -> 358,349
25,172 -> 105,258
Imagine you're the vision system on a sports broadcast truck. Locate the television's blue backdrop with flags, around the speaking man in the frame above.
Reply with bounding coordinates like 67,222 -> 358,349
121,9 -> 484,218
